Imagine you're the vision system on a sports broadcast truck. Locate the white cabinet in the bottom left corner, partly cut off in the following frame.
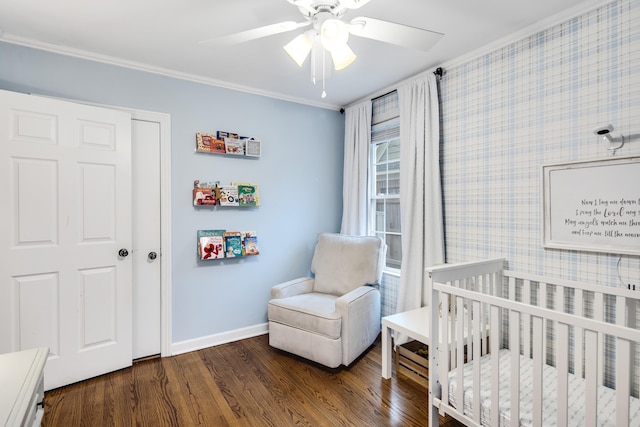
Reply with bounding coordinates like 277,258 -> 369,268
0,347 -> 49,427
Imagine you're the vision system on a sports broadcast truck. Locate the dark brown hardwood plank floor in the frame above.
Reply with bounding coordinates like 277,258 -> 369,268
42,335 -> 459,427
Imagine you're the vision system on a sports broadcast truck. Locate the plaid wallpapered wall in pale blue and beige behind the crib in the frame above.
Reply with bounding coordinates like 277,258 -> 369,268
440,0 -> 640,286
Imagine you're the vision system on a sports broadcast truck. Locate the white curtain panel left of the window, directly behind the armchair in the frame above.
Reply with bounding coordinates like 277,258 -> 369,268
340,100 -> 371,236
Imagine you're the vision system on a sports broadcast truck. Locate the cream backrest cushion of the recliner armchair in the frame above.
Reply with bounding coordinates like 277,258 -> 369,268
311,233 -> 385,296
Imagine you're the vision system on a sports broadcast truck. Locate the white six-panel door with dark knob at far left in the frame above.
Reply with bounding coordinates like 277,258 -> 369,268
0,91 -> 132,389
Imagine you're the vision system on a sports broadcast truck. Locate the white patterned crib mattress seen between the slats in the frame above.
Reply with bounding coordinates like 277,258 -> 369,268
449,350 -> 640,427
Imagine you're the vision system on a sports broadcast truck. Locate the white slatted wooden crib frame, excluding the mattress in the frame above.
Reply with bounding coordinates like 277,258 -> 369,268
427,260 -> 640,426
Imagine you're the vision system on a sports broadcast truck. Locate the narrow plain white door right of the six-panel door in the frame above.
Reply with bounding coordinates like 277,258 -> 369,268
131,119 -> 162,359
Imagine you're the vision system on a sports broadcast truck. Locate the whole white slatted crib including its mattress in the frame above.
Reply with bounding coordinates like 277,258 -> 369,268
427,259 -> 640,426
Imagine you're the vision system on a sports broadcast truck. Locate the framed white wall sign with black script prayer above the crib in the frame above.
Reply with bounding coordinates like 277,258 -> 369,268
542,156 -> 640,255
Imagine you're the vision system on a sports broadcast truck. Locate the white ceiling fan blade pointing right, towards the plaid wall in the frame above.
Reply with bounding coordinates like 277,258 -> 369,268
349,17 -> 443,52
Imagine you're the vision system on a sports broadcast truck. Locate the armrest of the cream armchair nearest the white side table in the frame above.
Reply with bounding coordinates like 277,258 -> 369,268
336,286 -> 380,366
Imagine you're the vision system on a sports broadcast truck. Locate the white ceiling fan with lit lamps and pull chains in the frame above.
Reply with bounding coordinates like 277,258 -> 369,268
200,0 -> 443,97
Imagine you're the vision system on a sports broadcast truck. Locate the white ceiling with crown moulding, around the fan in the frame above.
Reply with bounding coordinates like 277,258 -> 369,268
0,0 -> 602,108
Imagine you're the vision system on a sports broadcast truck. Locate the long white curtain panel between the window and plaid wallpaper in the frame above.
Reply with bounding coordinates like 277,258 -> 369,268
396,73 -> 444,320
